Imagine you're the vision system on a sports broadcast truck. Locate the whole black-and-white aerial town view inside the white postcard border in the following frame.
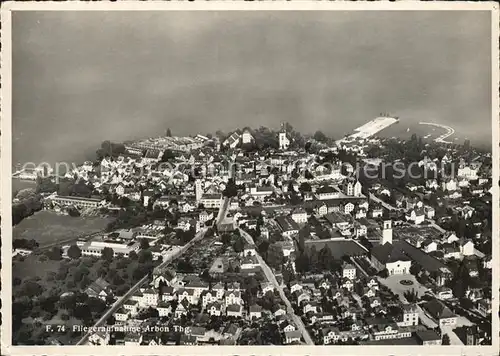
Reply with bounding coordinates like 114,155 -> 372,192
9,11 -> 496,347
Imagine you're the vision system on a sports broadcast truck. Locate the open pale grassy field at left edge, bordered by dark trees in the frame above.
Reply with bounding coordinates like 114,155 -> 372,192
13,210 -> 112,247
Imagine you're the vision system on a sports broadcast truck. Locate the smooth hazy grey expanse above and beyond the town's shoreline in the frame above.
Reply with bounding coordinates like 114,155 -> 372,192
13,11 -> 491,162
